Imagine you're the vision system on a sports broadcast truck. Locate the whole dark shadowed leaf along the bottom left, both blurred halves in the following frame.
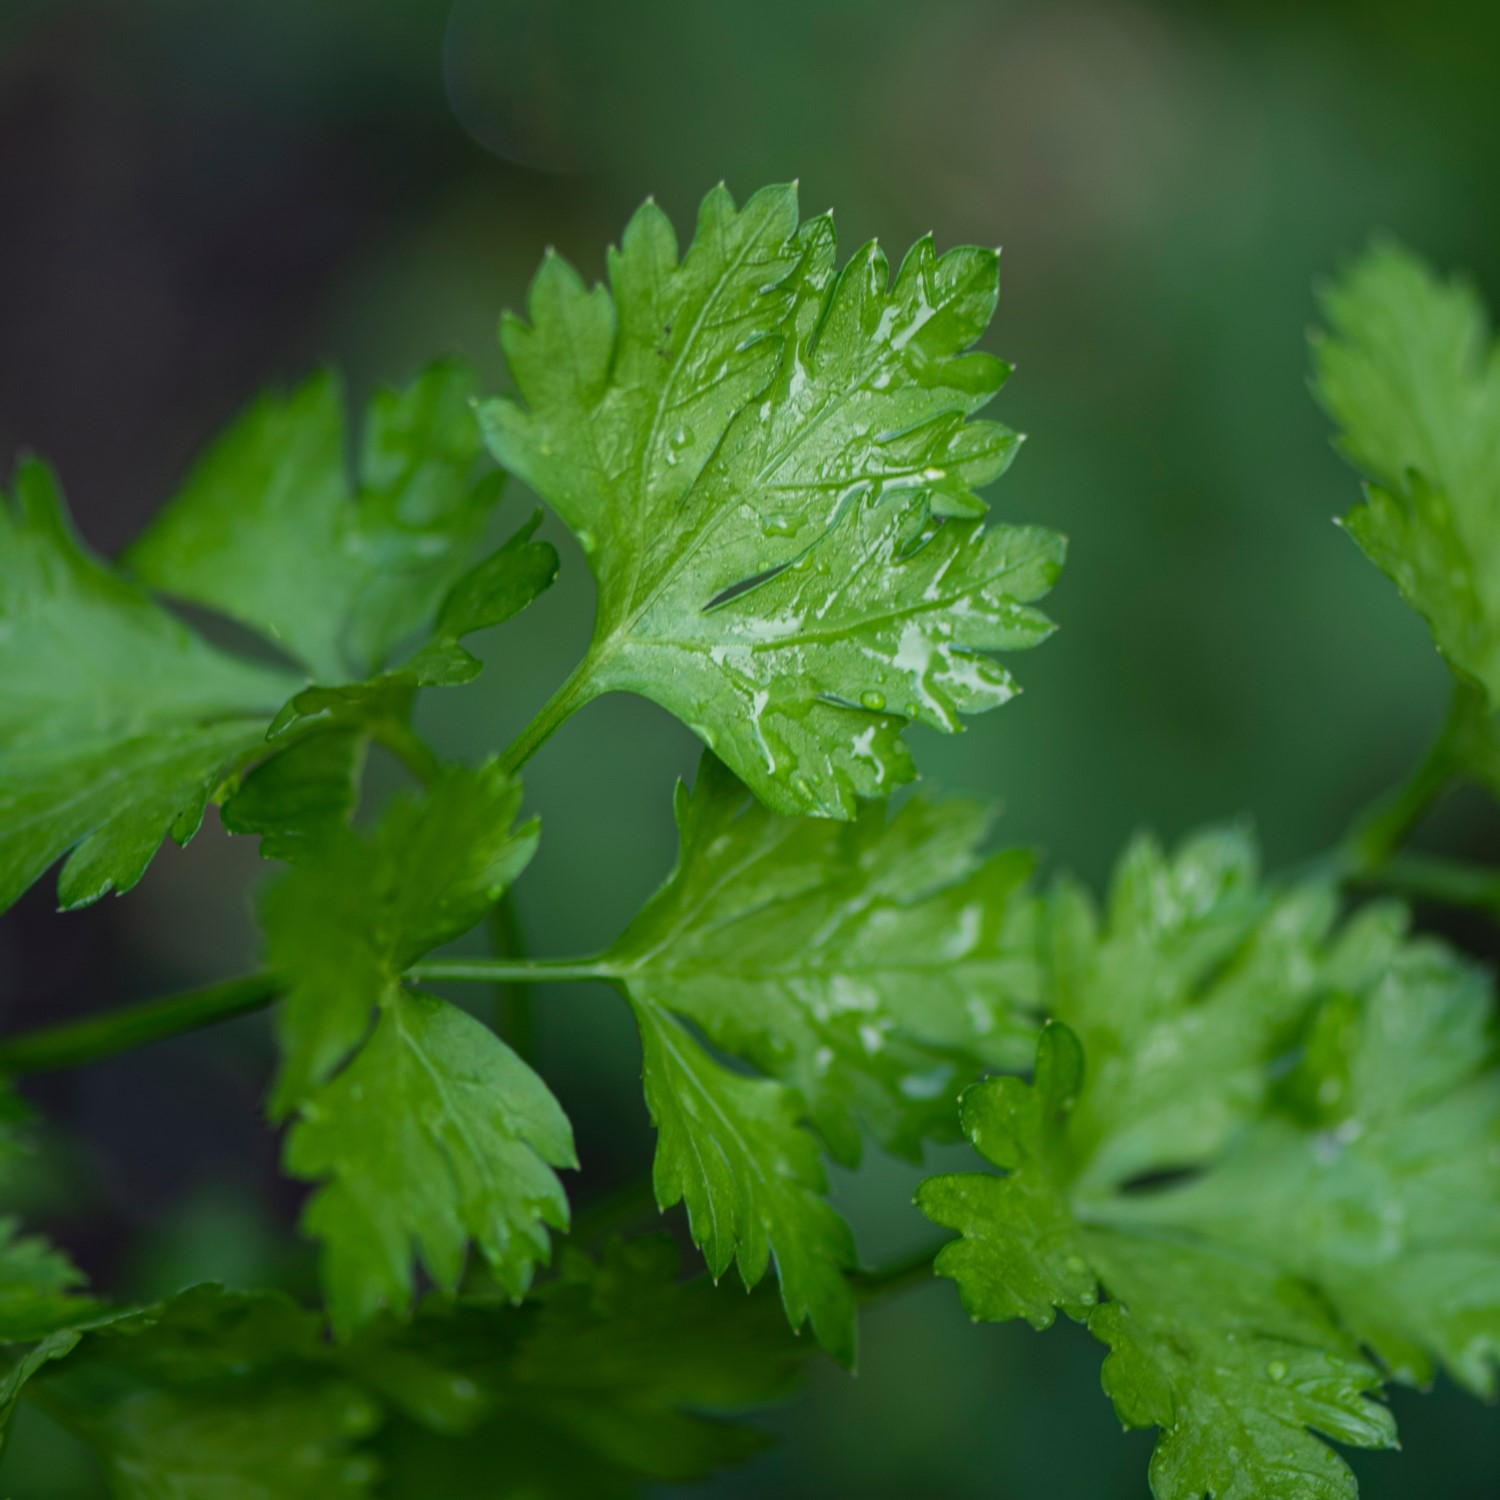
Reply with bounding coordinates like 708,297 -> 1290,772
0,1236 -> 806,1500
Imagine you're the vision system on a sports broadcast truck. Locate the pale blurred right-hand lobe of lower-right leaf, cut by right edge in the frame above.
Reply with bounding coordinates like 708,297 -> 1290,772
1122,908 -> 1500,1398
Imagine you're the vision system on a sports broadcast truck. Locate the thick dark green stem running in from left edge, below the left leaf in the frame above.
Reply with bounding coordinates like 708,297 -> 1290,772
0,974 -> 284,1077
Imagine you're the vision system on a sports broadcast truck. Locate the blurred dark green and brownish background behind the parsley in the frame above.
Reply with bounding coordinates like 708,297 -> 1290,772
0,0 -> 1500,1500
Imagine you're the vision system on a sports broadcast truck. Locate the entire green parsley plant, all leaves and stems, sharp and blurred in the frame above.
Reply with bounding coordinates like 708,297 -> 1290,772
0,188 -> 1500,1500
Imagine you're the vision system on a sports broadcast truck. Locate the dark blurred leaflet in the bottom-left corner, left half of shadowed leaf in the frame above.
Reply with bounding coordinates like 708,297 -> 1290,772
8,1287 -> 380,1500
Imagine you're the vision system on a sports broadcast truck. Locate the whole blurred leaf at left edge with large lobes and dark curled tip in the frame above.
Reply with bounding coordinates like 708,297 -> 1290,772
0,366 -> 557,909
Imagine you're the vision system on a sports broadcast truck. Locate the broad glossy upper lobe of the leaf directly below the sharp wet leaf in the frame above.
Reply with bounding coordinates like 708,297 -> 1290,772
603,755 -> 1038,1164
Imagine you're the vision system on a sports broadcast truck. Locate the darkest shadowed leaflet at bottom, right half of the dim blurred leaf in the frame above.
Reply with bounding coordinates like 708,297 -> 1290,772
347,1236 -> 807,1500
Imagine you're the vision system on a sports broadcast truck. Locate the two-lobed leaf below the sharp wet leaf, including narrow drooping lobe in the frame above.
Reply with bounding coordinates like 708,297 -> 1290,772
599,755 -> 1037,1362
